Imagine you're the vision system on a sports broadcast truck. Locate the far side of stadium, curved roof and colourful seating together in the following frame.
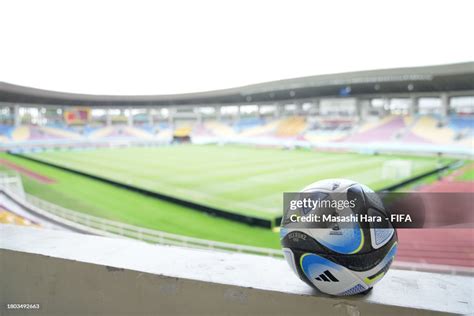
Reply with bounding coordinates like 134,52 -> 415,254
0,62 -> 474,155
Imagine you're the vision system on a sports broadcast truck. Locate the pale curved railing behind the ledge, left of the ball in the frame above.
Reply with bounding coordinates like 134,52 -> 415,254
0,176 -> 283,257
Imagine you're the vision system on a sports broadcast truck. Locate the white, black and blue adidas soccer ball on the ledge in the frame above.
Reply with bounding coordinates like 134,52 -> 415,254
280,179 -> 398,296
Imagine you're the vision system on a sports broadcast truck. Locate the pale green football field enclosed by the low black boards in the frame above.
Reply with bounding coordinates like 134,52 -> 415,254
22,145 -> 448,219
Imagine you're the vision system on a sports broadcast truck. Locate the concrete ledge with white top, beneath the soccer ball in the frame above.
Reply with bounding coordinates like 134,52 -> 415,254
0,225 -> 474,316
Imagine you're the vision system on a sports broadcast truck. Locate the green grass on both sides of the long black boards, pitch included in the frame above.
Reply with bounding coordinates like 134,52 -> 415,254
0,145 -> 452,248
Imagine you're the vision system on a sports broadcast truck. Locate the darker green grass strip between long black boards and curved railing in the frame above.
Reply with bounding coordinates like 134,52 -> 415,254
0,153 -> 279,249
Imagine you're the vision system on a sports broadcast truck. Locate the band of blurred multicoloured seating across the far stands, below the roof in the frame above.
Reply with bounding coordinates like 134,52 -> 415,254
0,115 -> 474,147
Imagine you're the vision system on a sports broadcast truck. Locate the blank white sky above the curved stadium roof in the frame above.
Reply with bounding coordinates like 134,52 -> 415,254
0,0 -> 474,95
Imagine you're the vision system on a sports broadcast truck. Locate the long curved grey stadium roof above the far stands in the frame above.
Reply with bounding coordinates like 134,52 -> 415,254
0,62 -> 474,106
